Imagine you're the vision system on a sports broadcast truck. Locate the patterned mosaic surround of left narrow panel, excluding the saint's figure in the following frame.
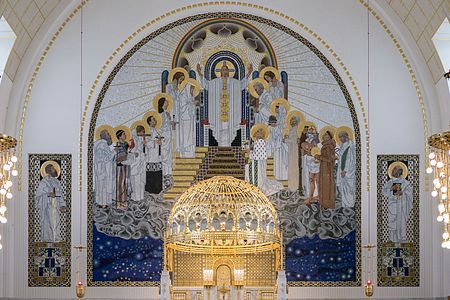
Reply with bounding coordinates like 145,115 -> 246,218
28,154 -> 72,287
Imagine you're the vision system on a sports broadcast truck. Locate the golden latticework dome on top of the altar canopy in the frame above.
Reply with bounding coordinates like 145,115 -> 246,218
166,176 -> 280,254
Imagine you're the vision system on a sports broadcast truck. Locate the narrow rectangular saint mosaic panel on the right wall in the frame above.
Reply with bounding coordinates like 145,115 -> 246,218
377,155 -> 420,287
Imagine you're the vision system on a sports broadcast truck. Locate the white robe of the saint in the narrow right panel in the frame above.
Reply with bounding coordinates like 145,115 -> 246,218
382,177 -> 413,243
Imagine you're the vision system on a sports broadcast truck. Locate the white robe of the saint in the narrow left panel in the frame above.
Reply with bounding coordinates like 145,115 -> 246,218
35,176 -> 66,243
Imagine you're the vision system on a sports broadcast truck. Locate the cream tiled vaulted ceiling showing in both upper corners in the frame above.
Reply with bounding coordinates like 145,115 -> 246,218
0,0 -> 450,82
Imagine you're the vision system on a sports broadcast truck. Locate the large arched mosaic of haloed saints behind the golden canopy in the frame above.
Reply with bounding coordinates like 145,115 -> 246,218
88,13 -> 361,286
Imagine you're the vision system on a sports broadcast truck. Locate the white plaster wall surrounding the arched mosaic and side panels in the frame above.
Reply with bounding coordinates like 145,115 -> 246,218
0,0 -> 450,299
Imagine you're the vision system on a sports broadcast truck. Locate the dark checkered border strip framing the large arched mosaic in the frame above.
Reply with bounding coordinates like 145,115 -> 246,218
87,12 -> 361,287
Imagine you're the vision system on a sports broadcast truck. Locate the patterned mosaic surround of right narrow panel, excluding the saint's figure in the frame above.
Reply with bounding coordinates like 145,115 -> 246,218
377,154 -> 420,287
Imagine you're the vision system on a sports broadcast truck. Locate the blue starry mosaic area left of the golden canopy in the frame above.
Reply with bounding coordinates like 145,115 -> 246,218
92,226 -> 163,281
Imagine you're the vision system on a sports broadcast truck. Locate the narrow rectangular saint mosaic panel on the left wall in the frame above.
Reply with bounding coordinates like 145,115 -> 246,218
28,154 -> 72,287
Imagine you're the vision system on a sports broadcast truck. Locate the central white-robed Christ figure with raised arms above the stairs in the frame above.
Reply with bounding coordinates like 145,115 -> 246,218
197,61 -> 253,147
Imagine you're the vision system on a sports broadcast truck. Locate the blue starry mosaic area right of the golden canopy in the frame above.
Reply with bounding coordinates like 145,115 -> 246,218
285,230 -> 356,281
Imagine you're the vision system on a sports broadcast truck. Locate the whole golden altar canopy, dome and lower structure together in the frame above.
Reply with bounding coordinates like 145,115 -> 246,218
165,176 -> 282,286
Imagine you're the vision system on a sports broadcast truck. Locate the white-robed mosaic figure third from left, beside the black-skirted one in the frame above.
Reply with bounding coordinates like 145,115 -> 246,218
130,129 -> 147,201
